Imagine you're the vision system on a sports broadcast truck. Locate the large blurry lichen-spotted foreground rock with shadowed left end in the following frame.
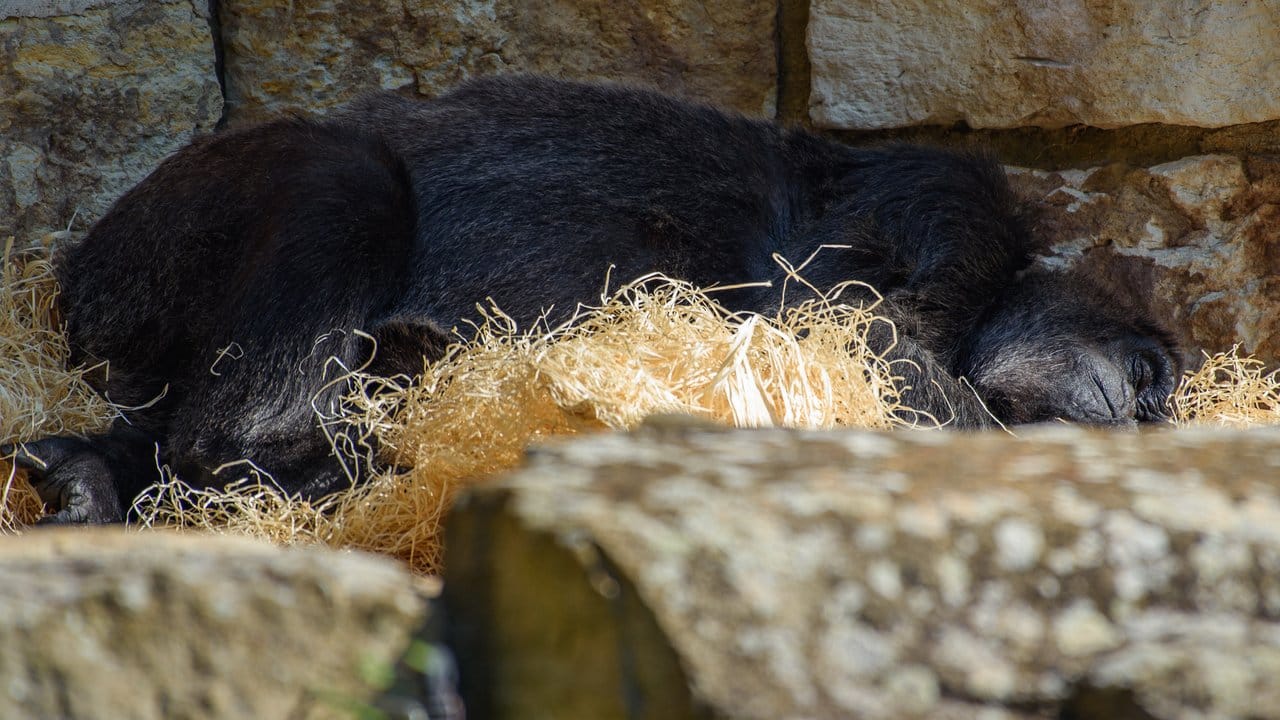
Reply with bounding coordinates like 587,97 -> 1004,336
445,420 -> 1280,720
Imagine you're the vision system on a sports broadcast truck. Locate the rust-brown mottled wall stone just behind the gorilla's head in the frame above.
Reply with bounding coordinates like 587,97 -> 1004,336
1012,155 -> 1280,364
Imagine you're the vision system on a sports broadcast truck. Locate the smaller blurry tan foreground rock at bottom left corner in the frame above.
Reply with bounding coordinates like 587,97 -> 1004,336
0,529 -> 425,720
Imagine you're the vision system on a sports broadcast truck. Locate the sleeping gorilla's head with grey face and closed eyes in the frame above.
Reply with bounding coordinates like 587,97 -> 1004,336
959,269 -> 1180,425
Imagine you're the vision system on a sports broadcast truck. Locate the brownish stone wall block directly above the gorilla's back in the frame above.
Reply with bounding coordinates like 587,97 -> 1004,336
219,0 -> 777,122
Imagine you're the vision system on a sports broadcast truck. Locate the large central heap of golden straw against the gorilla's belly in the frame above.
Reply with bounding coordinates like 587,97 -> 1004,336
127,271 -> 900,571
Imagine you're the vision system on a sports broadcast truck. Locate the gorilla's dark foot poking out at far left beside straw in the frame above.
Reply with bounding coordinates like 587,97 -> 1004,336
0,437 -> 124,525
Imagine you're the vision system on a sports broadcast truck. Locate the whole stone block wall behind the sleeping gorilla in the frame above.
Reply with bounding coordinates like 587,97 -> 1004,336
0,0 -> 1280,363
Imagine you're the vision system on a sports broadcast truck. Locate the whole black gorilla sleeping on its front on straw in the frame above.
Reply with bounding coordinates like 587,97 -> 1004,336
4,77 -> 1176,523
